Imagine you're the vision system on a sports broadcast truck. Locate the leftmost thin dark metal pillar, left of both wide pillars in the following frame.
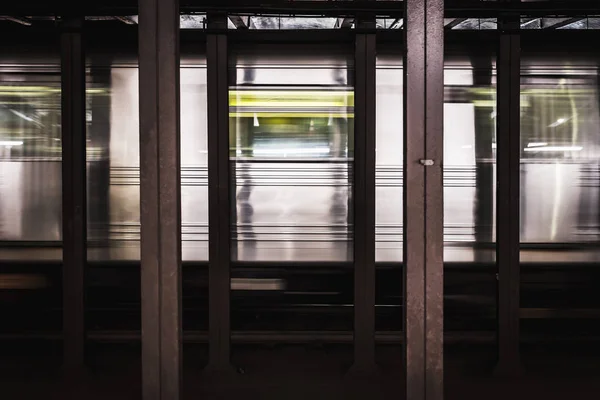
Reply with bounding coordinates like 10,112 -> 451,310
61,17 -> 87,374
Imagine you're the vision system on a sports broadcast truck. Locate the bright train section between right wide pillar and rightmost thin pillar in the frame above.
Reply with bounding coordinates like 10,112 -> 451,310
444,66 -> 496,262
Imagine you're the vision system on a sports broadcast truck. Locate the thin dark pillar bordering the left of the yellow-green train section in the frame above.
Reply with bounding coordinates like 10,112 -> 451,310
206,13 -> 231,373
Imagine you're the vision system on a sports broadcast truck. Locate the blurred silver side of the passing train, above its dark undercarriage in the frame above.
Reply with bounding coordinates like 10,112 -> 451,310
0,49 -> 600,262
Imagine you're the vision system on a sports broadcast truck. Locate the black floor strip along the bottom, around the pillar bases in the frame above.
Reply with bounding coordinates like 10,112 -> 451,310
0,345 -> 600,400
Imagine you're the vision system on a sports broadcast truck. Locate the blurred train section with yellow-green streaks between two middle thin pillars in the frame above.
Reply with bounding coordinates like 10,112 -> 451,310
229,66 -> 354,261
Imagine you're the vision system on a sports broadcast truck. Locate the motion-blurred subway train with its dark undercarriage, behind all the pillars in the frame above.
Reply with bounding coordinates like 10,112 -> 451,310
0,37 -> 600,336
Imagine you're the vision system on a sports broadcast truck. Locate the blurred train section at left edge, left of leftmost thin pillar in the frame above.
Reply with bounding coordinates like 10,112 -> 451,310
0,71 -> 62,245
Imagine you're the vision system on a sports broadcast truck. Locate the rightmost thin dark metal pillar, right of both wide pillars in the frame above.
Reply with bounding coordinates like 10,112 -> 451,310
496,16 -> 521,376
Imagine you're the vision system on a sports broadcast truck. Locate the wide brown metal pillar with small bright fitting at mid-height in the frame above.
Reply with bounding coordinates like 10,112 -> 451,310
404,0 -> 444,400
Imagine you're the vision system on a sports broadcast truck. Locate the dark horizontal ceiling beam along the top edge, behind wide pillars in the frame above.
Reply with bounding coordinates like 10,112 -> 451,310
2,0 -> 600,18
